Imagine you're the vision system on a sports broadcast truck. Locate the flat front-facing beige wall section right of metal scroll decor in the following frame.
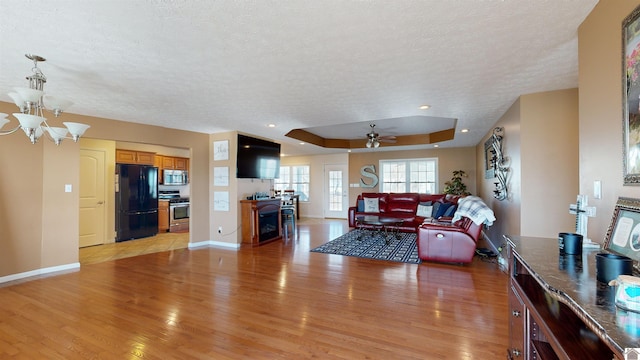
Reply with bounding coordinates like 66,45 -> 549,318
520,89 -> 579,237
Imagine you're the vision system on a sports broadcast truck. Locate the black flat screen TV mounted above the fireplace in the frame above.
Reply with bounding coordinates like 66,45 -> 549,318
236,134 -> 280,179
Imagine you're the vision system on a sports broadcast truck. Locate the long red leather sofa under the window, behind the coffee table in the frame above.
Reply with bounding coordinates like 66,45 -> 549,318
349,193 -> 459,233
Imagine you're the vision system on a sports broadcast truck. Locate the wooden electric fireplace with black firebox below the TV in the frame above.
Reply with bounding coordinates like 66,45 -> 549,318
240,199 -> 282,246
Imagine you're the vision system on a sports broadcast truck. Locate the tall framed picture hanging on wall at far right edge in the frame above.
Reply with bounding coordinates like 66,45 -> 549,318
622,6 -> 640,185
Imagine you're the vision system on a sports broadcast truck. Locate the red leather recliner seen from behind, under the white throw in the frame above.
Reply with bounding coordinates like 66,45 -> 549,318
418,217 -> 482,263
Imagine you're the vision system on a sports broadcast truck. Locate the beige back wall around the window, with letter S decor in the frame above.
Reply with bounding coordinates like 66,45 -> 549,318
349,147 -> 477,202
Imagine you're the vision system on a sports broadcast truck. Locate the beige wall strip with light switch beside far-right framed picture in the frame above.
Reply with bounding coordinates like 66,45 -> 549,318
578,0 -> 640,242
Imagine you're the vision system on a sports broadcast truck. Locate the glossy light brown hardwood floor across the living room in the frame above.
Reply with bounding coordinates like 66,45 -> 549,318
0,219 -> 508,359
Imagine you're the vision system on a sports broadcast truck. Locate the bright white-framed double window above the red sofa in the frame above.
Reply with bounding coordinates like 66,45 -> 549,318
380,158 -> 438,194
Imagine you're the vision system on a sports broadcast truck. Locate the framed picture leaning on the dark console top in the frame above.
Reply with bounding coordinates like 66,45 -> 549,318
603,197 -> 640,270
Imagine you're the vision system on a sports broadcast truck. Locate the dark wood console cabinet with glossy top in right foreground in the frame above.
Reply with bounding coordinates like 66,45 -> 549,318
507,236 -> 640,360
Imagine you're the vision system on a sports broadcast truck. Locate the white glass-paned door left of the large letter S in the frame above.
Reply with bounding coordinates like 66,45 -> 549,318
323,165 -> 349,219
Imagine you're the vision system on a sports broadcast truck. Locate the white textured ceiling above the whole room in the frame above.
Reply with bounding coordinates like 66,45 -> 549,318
0,0 -> 597,154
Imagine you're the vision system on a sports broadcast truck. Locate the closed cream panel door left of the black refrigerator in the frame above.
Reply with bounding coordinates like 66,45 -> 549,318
79,149 -> 106,247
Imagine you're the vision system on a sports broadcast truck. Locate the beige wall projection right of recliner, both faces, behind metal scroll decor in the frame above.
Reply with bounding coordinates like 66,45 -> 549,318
476,89 -> 578,245
